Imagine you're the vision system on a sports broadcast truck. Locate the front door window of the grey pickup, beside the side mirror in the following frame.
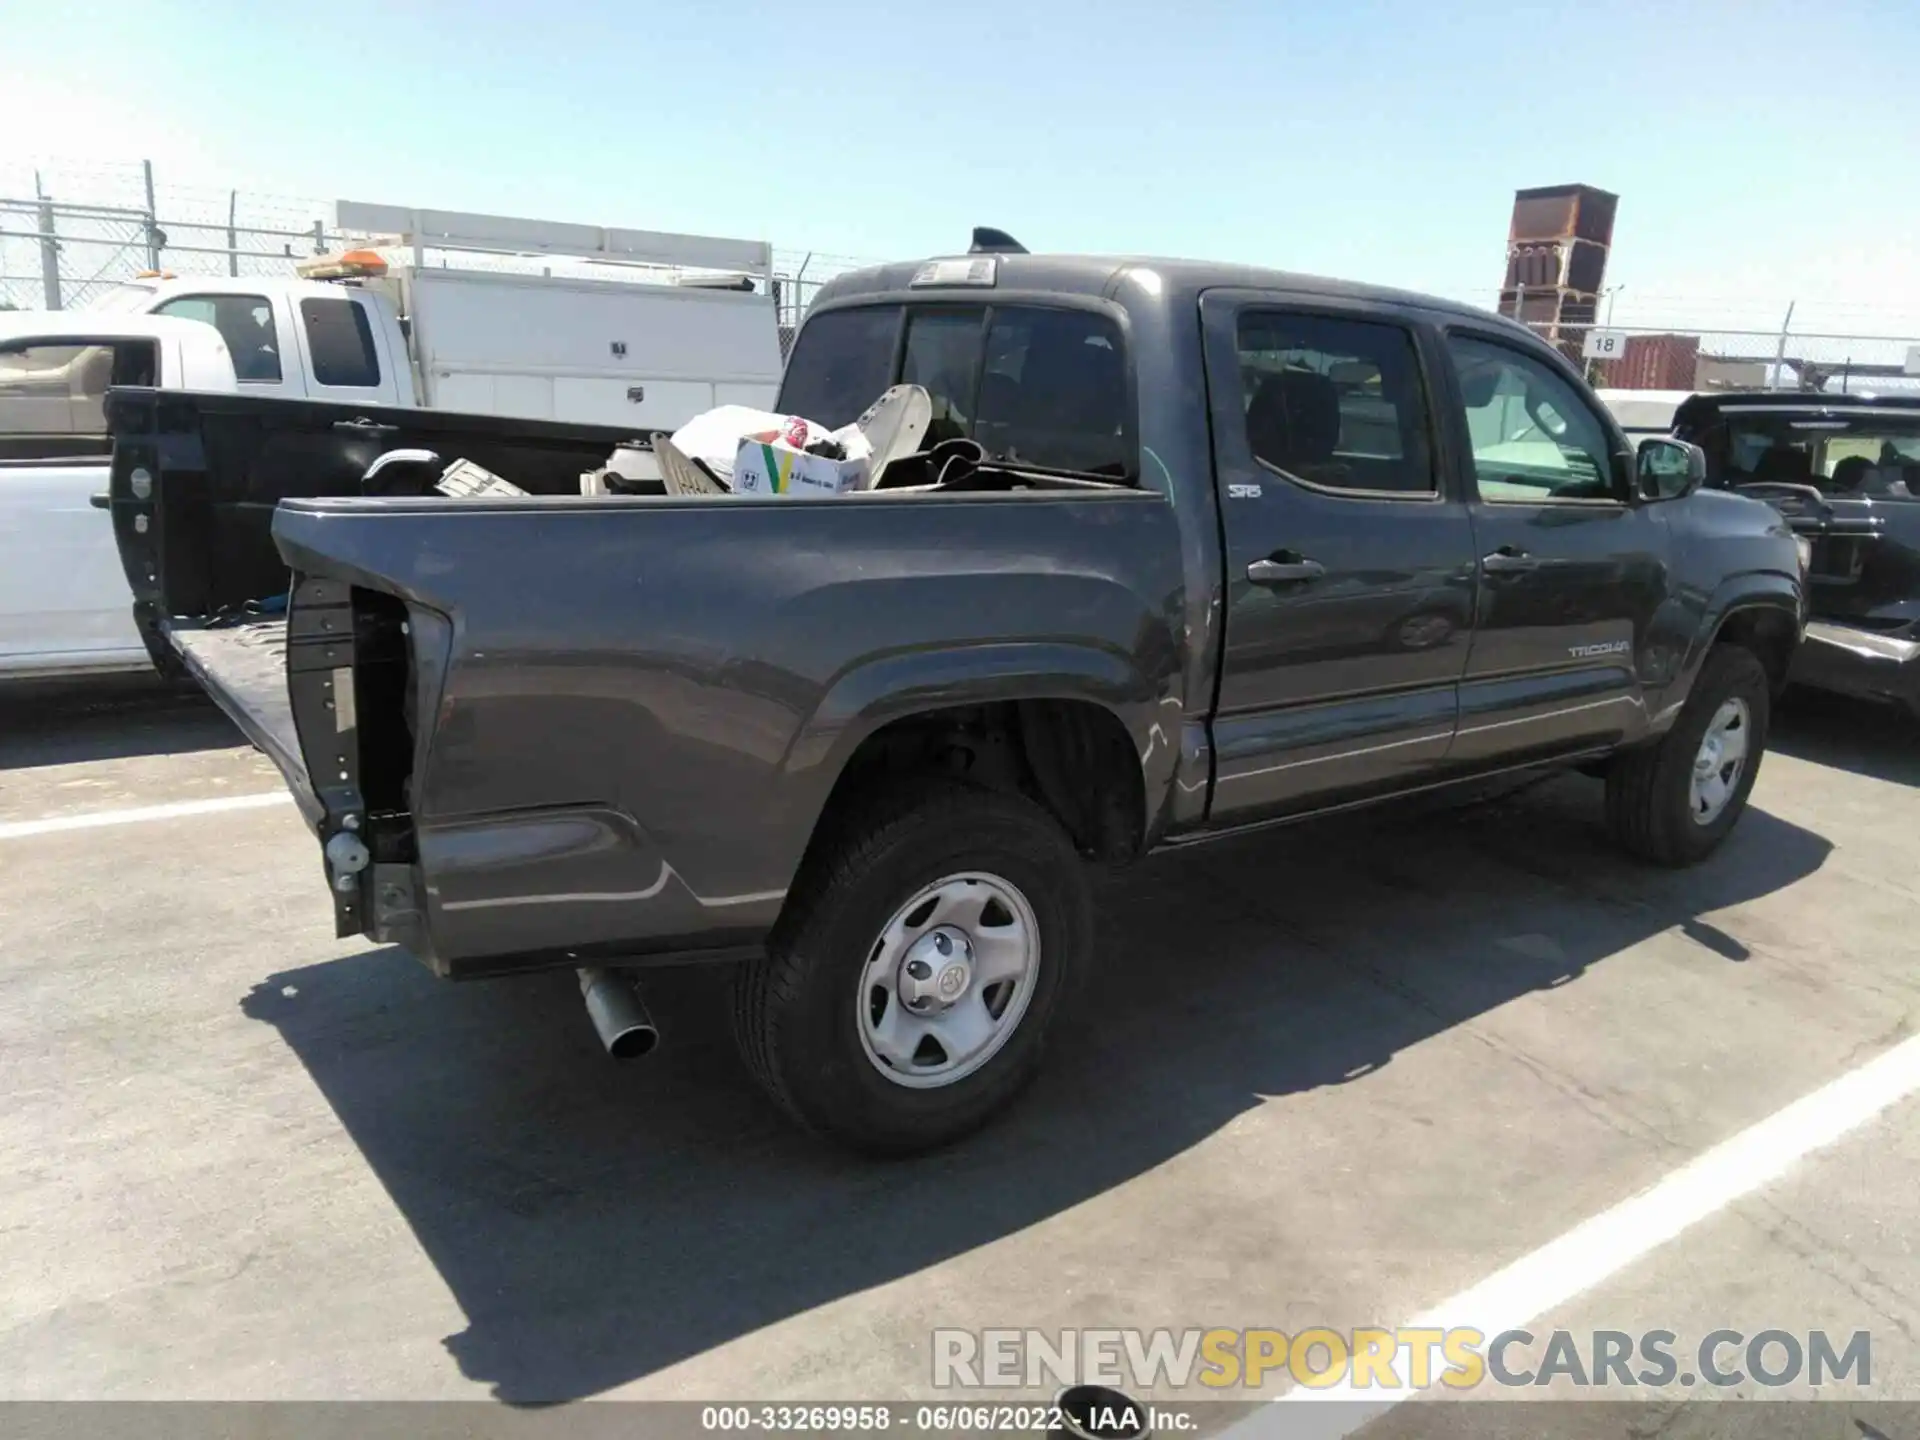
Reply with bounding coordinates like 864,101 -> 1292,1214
1448,336 -> 1620,503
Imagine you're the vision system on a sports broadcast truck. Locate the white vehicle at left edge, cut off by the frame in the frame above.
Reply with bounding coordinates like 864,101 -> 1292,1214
0,311 -> 236,680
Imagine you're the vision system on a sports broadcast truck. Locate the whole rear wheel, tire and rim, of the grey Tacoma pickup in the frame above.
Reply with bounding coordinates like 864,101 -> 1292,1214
733,781 -> 1091,1154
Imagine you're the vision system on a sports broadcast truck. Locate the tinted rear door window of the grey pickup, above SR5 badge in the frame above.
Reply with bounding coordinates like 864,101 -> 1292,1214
1238,311 -> 1440,495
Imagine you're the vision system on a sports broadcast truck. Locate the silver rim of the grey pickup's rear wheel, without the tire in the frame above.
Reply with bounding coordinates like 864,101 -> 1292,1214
856,872 -> 1041,1091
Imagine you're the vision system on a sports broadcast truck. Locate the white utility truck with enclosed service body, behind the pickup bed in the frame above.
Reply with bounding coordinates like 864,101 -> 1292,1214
72,202 -> 781,445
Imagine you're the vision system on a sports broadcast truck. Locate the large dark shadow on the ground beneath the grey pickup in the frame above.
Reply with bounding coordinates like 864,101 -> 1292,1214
244,778 -> 1830,1404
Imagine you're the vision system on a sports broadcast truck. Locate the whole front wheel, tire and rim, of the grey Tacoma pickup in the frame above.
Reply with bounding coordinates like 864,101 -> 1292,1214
1607,645 -> 1772,866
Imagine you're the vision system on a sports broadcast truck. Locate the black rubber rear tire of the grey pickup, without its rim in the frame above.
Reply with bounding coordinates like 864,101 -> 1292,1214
733,781 -> 1092,1156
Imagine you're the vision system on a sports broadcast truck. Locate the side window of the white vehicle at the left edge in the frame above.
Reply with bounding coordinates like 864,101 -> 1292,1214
0,340 -> 159,459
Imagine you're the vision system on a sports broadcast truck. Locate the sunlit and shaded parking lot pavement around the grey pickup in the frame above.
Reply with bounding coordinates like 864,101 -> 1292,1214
0,685 -> 1920,1436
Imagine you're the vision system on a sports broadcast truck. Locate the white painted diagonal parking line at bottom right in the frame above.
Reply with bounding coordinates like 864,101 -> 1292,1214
1227,1037 -> 1920,1440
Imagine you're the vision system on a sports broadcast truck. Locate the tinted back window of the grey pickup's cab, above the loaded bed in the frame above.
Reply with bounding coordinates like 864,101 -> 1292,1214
780,305 -> 1139,480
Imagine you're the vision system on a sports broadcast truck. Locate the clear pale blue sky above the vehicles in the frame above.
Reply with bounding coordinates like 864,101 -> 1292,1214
0,0 -> 1920,328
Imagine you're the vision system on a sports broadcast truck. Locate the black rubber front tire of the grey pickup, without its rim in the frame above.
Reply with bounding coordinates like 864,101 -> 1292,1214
1607,645 -> 1772,866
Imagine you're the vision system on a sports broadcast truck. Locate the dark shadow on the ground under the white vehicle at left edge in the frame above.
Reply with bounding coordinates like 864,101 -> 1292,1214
0,676 -> 246,770
